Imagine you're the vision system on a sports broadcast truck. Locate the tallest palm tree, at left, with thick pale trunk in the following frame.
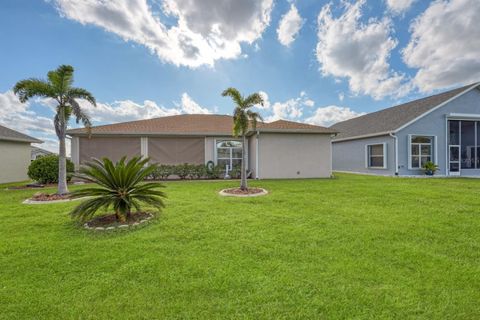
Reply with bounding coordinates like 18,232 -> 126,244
13,65 -> 96,194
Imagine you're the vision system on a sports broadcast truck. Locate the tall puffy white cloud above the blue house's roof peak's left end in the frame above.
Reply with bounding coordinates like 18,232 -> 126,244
316,0 -> 411,100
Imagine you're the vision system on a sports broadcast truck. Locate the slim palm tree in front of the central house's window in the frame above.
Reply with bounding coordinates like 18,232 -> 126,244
222,88 -> 263,190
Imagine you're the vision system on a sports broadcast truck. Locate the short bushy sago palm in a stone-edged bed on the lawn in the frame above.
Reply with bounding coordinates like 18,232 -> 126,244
70,157 -> 165,221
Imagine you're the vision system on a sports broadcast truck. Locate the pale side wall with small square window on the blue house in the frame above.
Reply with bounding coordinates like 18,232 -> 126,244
332,136 -> 395,175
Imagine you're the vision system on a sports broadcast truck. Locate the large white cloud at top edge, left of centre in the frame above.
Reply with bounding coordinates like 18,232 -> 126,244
55,0 -> 273,68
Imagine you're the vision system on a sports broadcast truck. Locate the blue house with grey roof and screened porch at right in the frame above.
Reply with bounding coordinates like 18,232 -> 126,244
331,83 -> 480,176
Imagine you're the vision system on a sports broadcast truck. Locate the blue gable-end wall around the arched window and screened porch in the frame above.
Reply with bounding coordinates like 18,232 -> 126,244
396,89 -> 480,175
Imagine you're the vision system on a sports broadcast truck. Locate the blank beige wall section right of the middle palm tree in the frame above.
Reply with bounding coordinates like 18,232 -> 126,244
257,133 -> 331,179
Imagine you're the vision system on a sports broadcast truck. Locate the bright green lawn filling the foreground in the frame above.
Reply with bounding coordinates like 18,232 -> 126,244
0,174 -> 480,319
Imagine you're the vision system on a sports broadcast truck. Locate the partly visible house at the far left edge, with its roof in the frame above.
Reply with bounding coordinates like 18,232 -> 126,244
0,126 -> 42,183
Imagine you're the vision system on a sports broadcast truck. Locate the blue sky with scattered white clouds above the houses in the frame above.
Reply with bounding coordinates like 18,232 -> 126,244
0,0 -> 480,150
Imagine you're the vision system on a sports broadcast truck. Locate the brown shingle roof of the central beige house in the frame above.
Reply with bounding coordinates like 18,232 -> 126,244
67,114 -> 335,136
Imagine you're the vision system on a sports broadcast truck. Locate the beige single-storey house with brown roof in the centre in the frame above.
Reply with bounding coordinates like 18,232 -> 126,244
68,114 -> 335,178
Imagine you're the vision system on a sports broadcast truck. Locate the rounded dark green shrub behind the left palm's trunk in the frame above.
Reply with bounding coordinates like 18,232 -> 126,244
28,155 -> 75,183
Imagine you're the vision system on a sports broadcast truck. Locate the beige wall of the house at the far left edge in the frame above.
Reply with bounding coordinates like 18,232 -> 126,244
0,141 -> 31,183
